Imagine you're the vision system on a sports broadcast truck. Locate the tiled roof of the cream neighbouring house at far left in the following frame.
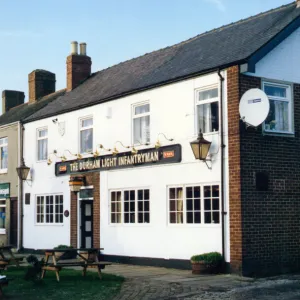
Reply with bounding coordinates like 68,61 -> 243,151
0,89 -> 66,126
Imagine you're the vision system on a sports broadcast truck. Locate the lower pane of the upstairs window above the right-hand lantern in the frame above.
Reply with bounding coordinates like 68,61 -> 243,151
197,102 -> 219,133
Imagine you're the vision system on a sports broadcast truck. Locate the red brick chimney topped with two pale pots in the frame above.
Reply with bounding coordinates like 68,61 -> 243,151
67,42 -> 92,92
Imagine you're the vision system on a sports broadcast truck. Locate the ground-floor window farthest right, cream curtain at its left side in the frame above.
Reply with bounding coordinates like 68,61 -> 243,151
168,185 -> 220,224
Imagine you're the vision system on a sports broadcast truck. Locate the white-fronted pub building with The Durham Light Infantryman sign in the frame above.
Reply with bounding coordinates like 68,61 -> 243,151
23,1 -> 300,276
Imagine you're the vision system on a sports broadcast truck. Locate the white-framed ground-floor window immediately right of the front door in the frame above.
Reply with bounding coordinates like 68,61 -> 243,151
110,189 -> 150,224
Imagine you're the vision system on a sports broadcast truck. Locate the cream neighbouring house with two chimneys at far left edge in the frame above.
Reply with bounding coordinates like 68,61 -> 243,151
0,70 -> 65,247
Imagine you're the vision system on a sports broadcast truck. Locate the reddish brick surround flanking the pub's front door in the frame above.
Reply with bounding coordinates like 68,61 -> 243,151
70,172 -> 100,248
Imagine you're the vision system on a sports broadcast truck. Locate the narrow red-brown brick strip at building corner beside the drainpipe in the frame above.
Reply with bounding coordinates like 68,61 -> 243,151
227,66 -> 242,273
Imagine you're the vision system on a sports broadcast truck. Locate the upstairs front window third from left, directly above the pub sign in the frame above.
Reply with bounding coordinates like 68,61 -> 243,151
133,103 -> 150,144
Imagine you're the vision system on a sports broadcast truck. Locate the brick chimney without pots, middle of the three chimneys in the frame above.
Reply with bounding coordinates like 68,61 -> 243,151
28,70 -> 56,103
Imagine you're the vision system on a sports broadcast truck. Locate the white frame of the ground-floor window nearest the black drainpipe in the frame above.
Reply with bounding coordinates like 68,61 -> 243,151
166,182 -> 222,228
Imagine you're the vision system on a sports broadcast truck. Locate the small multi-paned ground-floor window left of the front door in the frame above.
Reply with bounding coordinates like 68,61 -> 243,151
36,195 -> 64,224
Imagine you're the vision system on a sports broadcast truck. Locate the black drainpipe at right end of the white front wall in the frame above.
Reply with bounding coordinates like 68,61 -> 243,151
218,69 -> 227,268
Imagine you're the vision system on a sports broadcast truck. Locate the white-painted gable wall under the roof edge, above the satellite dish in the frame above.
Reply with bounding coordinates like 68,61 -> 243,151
246,28 -> 300,82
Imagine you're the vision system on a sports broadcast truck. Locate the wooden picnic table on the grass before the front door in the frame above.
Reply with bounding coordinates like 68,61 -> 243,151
41,248 -> 111,281
